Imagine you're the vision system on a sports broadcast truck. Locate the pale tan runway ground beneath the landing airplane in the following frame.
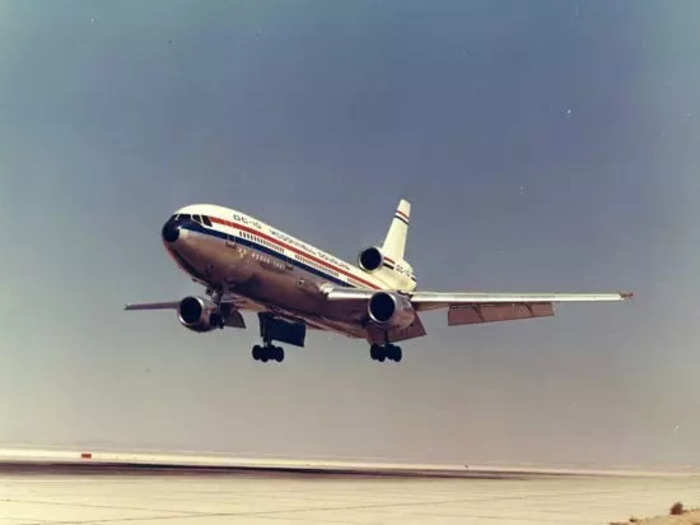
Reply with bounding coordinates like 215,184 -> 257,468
0,448 -> 700,525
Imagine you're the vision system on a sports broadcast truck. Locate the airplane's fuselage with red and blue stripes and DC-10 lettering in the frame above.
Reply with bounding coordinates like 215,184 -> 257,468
163,204 -> 413,337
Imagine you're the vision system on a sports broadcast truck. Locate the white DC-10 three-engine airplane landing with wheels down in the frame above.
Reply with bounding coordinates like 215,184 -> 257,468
125,199 -> 633,362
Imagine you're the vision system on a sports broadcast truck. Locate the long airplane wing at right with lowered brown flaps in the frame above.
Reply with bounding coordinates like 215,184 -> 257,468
326,288 -> 632,325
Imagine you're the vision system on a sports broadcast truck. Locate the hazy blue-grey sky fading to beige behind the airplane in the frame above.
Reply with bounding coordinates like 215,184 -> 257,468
0,1 -> 700,465
